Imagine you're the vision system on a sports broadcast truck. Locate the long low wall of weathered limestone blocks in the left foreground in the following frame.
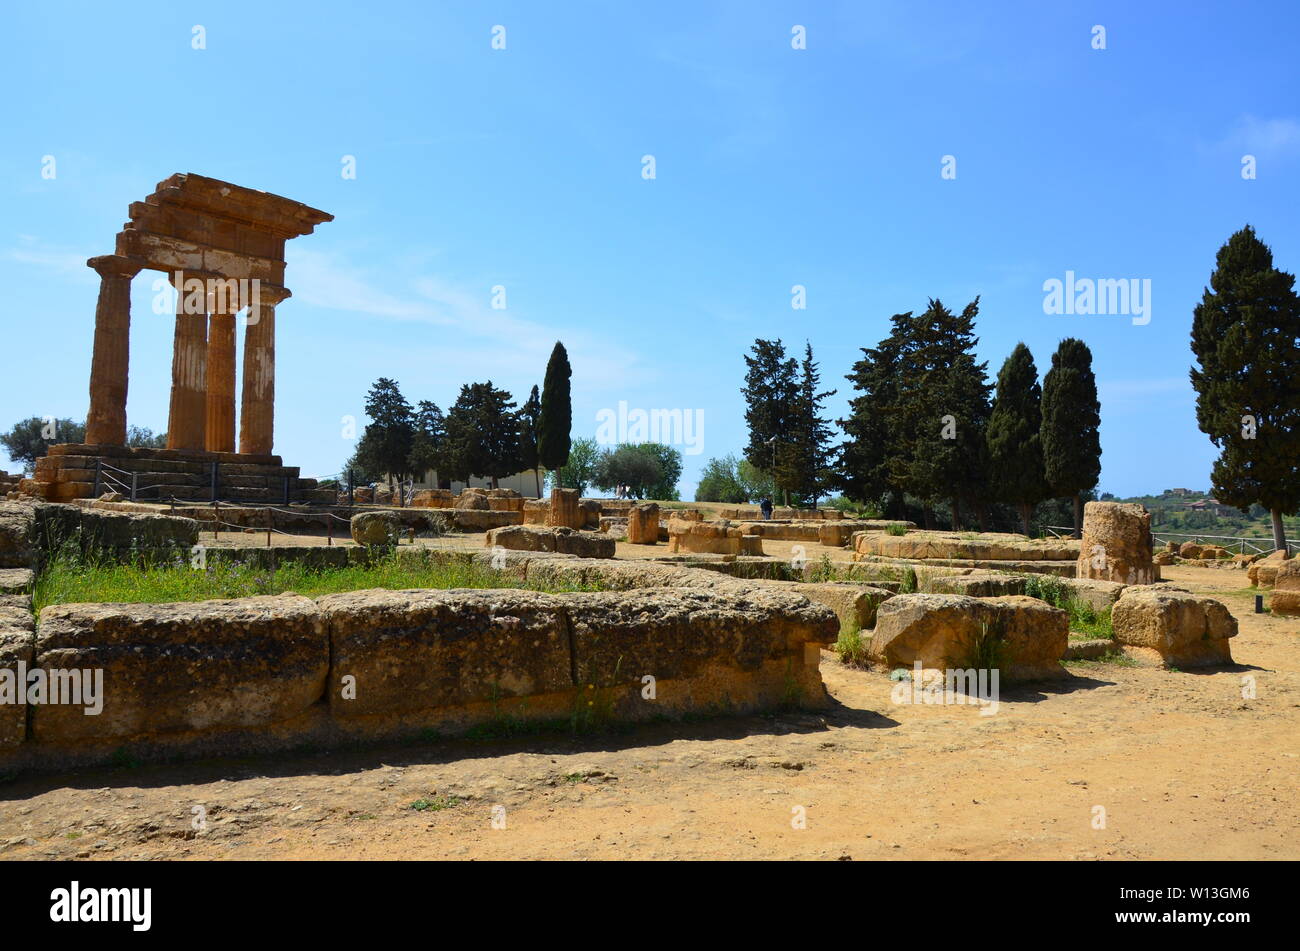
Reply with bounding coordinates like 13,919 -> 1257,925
0,576 -> 840,769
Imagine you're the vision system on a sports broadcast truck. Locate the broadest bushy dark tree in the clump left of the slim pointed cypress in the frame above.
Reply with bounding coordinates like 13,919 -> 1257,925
443,379 -> 520,488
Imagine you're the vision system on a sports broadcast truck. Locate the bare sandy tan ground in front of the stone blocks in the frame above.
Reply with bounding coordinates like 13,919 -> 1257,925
0,568 -> 1300,859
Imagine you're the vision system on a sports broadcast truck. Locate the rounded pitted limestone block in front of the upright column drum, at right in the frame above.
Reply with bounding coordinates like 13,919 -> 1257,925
1110,586 -> 1236,668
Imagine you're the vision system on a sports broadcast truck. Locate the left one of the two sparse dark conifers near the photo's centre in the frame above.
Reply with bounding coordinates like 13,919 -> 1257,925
741,339 -> 801,504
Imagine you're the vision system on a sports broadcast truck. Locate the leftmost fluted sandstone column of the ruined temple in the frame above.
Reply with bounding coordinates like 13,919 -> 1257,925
86,255 -> 142,446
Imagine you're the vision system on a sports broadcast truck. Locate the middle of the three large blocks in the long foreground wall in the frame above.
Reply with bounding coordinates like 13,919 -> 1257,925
317,590 -> 573,720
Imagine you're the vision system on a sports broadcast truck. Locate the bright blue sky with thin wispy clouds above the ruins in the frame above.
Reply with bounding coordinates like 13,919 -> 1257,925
0,0 -> 1300,498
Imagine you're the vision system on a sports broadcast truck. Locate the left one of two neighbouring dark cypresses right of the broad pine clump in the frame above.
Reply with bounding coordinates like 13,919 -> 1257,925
988,343 -> 1049,535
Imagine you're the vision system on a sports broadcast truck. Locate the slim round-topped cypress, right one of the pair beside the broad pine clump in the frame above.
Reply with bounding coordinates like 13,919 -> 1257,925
1041,336 -> 1101,538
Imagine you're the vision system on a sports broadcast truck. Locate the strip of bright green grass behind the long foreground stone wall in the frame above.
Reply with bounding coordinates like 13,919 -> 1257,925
33,552 -> 599,616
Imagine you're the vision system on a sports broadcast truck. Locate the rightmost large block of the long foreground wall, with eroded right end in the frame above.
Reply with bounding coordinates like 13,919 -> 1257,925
566,589 -> 840,716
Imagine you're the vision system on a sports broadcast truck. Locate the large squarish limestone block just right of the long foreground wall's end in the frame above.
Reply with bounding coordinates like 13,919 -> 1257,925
870,594 -> 1070,681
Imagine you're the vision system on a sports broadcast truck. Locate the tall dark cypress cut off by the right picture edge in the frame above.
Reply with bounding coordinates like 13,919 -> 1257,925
1191,225 -> 1300,551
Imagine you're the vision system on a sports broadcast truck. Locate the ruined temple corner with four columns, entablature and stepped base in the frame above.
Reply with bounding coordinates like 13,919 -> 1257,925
23,174 -> 333,501
